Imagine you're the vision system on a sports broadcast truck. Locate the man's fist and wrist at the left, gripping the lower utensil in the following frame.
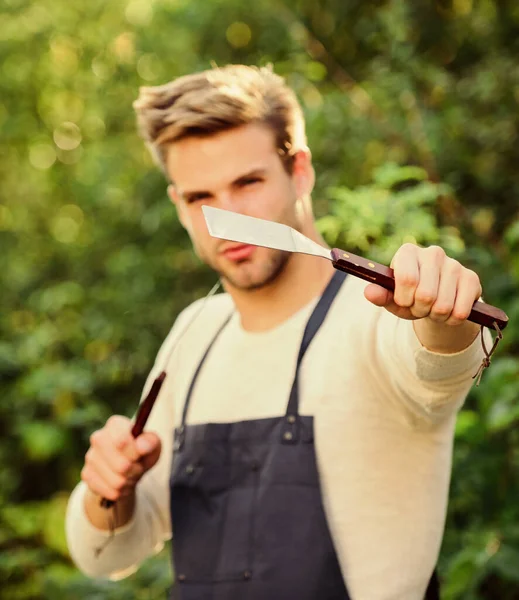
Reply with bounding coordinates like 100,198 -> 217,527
81,415 -> 161,529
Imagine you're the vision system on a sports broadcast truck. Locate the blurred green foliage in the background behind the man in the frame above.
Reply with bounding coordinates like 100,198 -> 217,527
0,0 -> 519,600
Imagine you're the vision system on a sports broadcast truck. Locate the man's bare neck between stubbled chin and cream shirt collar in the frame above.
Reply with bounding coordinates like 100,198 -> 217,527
224,226 -> 334,331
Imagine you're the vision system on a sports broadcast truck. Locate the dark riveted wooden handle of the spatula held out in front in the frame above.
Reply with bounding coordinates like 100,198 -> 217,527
331,248 -> 508,330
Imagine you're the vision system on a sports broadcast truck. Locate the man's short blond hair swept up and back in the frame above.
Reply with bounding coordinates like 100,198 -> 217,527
133,65 -> 306,175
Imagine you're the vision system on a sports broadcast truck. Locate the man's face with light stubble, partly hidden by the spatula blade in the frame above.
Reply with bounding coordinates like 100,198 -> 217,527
167,124 -> 311,290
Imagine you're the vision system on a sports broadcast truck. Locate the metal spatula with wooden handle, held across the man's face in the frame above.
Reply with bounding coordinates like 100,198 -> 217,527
202,205 -> 508,329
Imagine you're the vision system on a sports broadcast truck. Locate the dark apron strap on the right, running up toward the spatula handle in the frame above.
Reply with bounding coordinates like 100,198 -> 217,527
281,271 -> 346,444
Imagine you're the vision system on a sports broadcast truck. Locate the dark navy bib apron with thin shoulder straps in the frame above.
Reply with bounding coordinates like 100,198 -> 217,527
170,271 -> 437,600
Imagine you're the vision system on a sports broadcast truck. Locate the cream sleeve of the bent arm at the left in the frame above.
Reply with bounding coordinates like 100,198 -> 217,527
65,302 -> 203,579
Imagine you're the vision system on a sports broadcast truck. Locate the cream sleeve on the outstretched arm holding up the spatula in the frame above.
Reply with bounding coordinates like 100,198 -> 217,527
374,309 -> 492,424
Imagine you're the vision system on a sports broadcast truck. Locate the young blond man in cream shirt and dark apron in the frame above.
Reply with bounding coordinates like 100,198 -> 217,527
67,66 -> 490,600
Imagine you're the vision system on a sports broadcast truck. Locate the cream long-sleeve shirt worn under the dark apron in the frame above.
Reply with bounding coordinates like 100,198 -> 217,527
66,277 -> 483,600
